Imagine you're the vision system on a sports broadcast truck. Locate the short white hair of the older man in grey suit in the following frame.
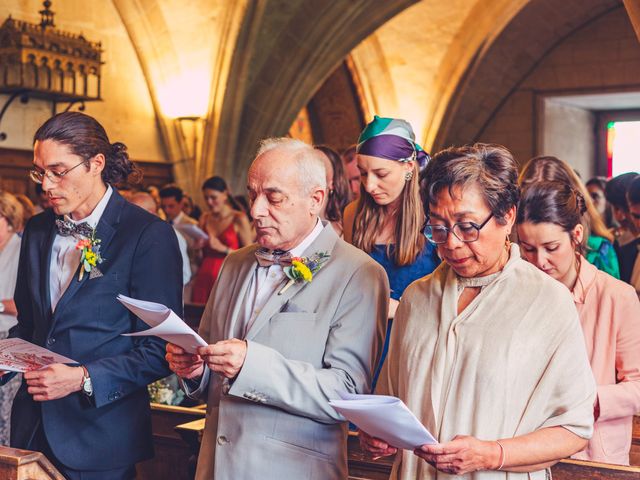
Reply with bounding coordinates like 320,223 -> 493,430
256,137 -> 327,193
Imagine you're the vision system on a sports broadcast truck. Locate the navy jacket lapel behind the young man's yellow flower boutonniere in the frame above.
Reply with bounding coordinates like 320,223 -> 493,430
52,189 -> 125,327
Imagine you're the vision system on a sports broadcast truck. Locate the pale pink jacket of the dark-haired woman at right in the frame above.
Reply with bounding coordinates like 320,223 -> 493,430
573,257 -> 640,465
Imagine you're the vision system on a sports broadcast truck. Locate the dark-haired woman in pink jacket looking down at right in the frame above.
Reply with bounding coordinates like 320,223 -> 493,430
517,182 -> 640,465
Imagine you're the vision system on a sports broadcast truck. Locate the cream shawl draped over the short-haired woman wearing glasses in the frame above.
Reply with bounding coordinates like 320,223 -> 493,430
378,244 -> 596,480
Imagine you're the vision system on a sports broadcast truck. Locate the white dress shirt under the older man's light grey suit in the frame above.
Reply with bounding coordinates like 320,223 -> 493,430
242,219 -> 324,336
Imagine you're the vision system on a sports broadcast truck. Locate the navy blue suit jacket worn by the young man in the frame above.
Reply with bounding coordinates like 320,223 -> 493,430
10,191 -> 182,470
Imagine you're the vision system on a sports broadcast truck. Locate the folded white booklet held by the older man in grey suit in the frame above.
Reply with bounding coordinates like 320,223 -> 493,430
117,295 -> 207,353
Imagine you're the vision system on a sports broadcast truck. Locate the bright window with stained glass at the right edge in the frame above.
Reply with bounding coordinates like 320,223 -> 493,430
607,121 -> 640,177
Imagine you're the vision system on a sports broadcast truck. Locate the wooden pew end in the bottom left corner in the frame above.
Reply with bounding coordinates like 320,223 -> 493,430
0,446 -> 64,480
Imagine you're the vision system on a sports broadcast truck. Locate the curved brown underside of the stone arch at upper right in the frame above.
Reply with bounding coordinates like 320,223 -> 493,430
433,0 -> 621,150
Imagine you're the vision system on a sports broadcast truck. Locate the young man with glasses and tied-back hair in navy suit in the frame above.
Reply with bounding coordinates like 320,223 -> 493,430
5,112 -> 182,480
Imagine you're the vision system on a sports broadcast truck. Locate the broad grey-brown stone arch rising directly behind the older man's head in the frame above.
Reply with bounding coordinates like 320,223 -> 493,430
210,0 -> 416,189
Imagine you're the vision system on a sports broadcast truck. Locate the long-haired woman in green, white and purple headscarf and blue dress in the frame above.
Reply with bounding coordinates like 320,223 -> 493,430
344,115 -> 440,387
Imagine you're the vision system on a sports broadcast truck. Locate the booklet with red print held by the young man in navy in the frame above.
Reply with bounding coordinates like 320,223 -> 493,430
0,338 -> 78,372
